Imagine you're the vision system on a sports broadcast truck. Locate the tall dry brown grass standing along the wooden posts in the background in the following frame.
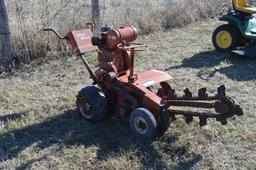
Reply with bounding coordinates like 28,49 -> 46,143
7,0 -> 231,63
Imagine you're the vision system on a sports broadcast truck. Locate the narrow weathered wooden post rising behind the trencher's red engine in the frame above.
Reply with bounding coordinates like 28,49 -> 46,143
91,0 -> 101,30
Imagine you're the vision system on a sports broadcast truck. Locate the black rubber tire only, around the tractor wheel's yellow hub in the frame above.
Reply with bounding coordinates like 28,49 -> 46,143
212,24 -> 241,52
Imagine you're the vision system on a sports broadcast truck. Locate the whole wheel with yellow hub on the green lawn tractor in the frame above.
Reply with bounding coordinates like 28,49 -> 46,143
212,25 -> 241,51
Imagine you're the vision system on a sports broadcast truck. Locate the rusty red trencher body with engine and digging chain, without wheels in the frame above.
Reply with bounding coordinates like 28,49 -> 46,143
44,23 -> 243,136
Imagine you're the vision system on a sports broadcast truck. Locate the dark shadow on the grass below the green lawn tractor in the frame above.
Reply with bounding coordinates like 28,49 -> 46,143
166,51 -> 256,81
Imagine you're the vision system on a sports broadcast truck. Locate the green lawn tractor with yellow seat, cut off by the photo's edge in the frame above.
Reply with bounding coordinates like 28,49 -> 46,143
212,0 -> 256,58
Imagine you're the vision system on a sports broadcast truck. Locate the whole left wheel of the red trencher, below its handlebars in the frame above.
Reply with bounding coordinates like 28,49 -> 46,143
76,86 -> 108,123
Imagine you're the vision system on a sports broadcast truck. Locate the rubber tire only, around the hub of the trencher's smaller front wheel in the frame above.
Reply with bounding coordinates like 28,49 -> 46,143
130,108 -> 157,141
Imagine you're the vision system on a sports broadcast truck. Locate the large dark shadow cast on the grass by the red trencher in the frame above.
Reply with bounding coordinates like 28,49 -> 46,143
0,110 -> 202,169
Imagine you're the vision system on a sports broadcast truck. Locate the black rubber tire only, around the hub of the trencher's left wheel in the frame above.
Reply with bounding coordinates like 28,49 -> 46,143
76,86 -> 108,123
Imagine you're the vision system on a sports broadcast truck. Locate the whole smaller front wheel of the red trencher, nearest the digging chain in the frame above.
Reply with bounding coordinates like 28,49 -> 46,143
130,108 -> 157,141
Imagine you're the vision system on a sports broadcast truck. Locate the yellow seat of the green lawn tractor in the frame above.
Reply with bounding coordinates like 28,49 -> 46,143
232,0 -> 256,15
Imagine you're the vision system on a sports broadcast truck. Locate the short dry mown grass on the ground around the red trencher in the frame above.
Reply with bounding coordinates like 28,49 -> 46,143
0,21 -> 256,169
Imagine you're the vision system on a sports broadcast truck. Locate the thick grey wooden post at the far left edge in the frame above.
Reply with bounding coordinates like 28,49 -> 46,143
0,0 -> 14,72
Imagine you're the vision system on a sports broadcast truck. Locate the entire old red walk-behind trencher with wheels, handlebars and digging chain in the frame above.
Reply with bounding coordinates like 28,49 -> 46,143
44,24 -> 243,140
